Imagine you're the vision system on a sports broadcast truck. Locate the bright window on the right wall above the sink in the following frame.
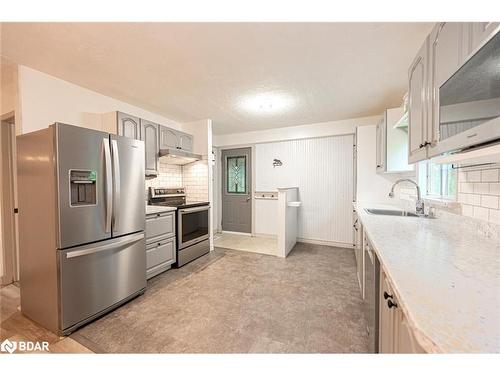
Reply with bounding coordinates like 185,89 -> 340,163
418,162 -> 457,200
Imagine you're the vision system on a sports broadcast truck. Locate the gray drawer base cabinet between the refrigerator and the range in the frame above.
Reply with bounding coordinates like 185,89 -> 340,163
146,211 -> 176,279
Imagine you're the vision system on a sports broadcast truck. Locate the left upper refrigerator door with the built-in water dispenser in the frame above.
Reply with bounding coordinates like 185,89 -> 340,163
56,123 -> 112,249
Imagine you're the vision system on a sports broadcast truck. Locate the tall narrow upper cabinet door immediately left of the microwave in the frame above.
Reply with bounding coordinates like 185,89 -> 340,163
408,38 -> 429,163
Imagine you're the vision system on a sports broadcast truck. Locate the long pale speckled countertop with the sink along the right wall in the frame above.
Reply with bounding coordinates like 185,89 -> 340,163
354,203 -> 500,353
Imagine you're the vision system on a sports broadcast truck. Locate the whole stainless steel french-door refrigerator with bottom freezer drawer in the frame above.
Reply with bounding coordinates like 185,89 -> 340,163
17,123 -> 146,334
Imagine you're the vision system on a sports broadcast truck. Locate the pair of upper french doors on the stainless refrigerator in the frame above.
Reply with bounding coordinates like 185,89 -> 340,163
56,124 -> 145,249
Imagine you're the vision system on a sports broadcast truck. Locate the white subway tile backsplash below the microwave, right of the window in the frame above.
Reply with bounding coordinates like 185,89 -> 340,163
457,165 -> 500,224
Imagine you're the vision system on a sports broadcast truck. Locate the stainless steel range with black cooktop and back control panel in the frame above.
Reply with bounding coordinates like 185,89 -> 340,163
149,187 -> 210,268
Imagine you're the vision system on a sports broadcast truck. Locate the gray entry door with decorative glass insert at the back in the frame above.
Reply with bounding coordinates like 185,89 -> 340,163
222,147 -> 252,233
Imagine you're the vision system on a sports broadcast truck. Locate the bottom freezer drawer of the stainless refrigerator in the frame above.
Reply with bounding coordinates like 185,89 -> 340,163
59,232 -> 146,332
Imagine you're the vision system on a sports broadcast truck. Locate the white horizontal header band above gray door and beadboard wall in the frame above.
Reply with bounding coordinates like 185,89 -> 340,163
214,116 -> 380,147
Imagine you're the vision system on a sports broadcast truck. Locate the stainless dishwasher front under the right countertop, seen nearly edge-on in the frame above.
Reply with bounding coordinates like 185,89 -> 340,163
363,241 -> 380,353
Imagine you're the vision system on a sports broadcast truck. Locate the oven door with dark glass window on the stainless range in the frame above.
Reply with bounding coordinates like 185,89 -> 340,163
177,206 -> 210,250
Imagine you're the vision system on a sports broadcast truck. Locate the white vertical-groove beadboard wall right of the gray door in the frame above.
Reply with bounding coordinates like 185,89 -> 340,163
255,135 -> 354,247
